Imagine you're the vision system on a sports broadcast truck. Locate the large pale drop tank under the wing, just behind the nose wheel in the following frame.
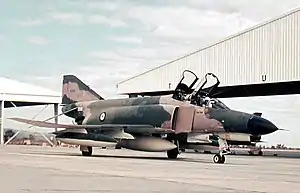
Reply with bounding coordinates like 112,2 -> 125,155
118,137 -> 177,152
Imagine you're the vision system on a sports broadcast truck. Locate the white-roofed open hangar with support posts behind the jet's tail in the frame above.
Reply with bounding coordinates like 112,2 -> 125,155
0,77 -> 61,144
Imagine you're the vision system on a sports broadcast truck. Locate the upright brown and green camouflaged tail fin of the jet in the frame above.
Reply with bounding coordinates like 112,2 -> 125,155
62,75 -> 104,104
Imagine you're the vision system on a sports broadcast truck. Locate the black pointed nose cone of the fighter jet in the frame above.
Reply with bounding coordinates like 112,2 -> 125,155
248,116 -> 278,135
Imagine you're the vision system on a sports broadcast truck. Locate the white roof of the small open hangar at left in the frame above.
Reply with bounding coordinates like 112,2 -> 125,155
0,77 -> 61,107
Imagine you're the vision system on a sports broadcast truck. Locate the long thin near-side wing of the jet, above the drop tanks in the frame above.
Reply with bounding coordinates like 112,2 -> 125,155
8,118 -> 174,133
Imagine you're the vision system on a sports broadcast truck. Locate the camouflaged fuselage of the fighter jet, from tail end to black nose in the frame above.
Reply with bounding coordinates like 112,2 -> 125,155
63,96 -> 277,144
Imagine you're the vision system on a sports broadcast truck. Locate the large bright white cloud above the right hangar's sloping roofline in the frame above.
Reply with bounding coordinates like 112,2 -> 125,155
128,6 -> 254,40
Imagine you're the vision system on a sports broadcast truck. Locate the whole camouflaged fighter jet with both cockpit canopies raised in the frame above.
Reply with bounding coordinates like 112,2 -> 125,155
10,71 -> 277,163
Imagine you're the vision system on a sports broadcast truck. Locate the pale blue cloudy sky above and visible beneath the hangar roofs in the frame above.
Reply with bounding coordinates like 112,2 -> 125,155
0,0 -> 300,146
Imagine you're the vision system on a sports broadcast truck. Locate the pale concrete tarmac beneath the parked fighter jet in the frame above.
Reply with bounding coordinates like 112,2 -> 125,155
0,145 -> 300,193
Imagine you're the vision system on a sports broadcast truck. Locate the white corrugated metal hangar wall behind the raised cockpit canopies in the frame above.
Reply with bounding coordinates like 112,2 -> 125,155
118,10 -> 300,93
